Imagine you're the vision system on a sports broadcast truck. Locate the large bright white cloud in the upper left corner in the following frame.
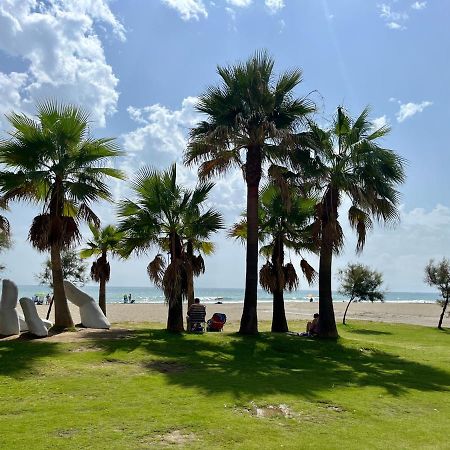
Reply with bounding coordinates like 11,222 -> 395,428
0,0 -> 125,126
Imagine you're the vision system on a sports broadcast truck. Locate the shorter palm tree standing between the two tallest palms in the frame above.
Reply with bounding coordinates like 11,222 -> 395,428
230,184 -> 317,332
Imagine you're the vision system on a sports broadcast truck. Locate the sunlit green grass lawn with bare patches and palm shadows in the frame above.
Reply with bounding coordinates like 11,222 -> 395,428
0,322 -> 450,450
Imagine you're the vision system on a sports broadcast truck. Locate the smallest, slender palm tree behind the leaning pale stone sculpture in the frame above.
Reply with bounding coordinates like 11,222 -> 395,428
80,223 -> 123,316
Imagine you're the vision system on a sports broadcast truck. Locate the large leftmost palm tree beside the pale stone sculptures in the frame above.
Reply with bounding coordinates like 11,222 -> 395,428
0,101 -> 123,328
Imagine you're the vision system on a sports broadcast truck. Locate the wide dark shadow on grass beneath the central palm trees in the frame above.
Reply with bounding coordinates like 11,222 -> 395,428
84,329 -> 450,399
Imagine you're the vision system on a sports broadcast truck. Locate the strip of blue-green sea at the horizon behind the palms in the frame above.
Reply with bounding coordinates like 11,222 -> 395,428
18,285 -> 439,303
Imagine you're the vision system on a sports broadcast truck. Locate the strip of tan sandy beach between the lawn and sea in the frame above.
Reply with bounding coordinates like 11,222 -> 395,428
37,302 -> 442,326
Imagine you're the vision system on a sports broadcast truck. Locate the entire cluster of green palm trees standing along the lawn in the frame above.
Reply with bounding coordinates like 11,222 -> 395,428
0,52 -> 404,337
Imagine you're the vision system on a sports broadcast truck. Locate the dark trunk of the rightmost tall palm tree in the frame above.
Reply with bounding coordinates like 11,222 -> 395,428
319,239 -> 338,338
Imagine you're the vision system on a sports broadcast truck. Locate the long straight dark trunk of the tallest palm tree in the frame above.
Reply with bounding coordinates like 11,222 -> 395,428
239,147 -> 261,334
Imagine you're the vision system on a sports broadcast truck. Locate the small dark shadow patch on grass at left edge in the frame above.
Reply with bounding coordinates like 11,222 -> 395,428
0,340 -> 60,378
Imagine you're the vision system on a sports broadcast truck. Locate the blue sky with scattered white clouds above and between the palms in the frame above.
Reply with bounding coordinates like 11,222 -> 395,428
0,0 -> 450,291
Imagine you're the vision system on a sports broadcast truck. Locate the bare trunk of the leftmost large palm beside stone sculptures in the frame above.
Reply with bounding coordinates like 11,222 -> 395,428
50,244 -> 73,328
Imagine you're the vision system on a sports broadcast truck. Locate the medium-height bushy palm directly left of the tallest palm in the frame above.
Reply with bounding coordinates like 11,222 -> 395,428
119,164 -> 222,331
